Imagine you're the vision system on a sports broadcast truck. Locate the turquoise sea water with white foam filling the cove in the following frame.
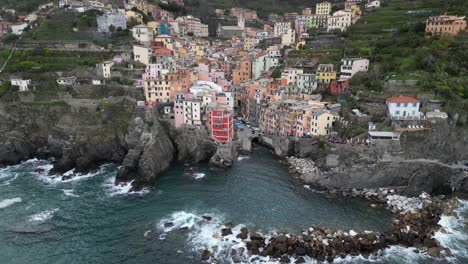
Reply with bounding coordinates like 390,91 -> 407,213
0,148 -> 466,264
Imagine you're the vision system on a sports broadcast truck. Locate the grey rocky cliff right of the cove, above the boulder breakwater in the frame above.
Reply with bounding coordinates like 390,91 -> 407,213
292,122 -> 468,196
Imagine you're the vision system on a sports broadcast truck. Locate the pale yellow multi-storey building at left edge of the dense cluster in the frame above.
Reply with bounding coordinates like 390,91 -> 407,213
143,74 -> 171,104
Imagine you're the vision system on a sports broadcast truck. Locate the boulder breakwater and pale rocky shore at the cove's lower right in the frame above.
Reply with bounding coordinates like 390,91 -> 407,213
202,193 -> 459,263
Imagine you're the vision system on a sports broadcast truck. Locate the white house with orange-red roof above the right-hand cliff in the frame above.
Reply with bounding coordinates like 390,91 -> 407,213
387,96 -> 421,119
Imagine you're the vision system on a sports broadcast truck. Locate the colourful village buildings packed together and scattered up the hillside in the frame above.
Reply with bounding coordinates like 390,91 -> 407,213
0,0 -> 467,151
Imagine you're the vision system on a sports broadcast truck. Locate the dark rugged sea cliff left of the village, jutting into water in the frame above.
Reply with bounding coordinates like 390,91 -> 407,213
0,98 -> 217,190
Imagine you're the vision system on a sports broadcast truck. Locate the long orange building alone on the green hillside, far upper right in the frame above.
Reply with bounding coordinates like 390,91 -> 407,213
426,15 -> 467,36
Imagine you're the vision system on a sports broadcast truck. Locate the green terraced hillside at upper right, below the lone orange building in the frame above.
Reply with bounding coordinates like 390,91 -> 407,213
345,0 -> 468,125
